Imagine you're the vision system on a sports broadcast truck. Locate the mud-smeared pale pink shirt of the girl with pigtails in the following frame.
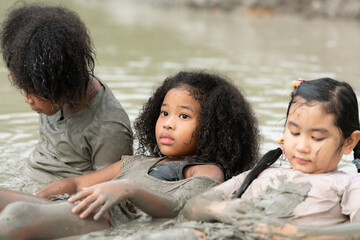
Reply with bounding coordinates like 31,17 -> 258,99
211,167 -> 360,226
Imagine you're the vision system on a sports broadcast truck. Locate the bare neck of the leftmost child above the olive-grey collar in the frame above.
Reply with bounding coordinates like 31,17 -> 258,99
61,77 -> 102,119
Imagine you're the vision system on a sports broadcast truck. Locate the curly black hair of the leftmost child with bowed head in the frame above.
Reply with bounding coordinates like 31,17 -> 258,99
0,4 -> 95,106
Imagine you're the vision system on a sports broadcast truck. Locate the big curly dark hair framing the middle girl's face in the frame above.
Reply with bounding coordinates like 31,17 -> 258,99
134,71 -> 259,179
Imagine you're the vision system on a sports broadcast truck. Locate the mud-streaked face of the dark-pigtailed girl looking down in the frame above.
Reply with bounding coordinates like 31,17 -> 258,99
284,98 -> 344,173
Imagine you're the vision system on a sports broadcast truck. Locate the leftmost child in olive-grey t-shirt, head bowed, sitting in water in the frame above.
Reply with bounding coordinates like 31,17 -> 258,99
0,4 -> 133,184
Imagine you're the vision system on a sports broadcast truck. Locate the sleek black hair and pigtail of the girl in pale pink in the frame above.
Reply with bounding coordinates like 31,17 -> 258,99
235,78 -> 360,198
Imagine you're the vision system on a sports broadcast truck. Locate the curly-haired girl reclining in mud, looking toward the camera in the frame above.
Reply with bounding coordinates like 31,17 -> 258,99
0,72 -> 258,239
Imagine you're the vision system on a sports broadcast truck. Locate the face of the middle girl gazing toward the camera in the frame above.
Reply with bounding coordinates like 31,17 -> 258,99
155,87 -> 200,157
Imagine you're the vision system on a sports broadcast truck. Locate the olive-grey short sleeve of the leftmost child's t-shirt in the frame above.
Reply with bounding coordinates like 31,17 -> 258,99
91,122 -> 133,170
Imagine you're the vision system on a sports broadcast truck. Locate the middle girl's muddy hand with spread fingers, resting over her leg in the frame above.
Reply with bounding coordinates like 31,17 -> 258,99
68,180 -> 132,220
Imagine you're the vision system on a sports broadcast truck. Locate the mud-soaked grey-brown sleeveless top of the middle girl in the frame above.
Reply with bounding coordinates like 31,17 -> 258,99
110,155 -> 219,226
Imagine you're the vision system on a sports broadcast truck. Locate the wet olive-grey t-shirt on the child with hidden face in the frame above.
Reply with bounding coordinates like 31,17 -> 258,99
25,82 -> 133,183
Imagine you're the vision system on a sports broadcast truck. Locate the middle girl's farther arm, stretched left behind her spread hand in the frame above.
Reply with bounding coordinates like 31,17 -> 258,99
34,161 -> 121,199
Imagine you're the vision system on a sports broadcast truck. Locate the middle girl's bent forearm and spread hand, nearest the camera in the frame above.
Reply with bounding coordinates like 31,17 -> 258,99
69,179 -> 181,220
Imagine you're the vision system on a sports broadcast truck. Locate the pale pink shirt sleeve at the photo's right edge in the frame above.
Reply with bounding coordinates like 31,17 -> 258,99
341,174 -> 360,215
